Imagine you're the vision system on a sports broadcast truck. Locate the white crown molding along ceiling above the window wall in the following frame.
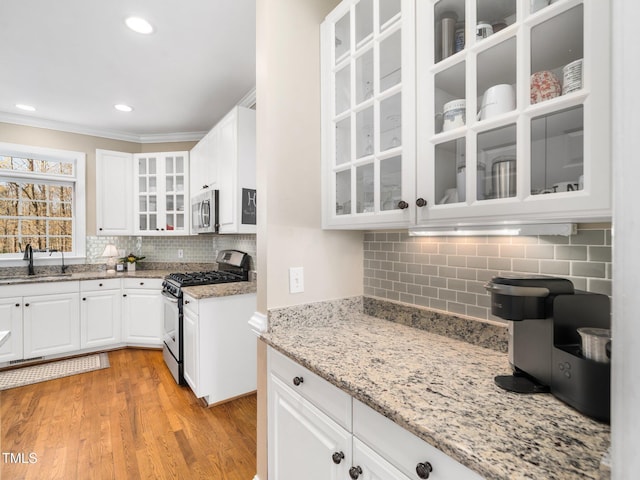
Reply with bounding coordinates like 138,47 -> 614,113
0,112 -> 207,143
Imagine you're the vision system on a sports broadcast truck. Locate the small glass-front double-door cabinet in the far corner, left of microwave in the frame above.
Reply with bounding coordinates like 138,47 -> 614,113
134,152 -> 189,235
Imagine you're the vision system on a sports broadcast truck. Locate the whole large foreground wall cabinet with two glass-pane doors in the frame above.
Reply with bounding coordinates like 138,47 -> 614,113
321,0 -> 611,228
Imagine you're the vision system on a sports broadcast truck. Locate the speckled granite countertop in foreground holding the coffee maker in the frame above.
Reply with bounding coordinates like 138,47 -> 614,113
262,302 -> 610,479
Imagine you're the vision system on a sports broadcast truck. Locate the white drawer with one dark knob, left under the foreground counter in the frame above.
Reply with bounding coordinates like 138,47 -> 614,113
268,348 -> 351,430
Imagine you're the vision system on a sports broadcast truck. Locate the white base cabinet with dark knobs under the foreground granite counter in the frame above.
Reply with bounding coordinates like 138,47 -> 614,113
267,347 -> 481,480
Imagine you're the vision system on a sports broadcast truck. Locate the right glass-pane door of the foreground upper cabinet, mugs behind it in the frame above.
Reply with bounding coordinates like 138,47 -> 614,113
416,0 -> 611,225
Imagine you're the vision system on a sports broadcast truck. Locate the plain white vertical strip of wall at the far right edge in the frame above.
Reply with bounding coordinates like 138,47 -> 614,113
611,0 -> 640,480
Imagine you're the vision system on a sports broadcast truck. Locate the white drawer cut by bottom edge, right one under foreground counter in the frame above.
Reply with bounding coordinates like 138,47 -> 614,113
353,399 -> 482,480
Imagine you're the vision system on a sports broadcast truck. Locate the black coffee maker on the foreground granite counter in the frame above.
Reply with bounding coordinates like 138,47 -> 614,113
486,276 -> 611,422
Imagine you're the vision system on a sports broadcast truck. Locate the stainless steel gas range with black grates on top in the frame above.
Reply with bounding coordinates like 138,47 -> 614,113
162,250 -> 250,385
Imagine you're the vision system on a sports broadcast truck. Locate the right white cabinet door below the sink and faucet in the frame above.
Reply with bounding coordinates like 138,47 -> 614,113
22,282 -> 80,358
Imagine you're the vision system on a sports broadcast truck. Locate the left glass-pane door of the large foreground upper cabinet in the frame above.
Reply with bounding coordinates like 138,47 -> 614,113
322,0 -> 415,228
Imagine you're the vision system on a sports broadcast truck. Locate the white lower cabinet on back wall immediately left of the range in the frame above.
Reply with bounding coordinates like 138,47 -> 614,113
122,278 -> 163,347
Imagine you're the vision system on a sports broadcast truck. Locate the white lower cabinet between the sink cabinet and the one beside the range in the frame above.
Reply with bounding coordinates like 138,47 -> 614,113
80,278 -> 123,348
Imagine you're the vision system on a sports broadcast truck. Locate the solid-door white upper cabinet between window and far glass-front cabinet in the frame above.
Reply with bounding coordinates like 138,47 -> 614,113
96,150 -> 133,235
